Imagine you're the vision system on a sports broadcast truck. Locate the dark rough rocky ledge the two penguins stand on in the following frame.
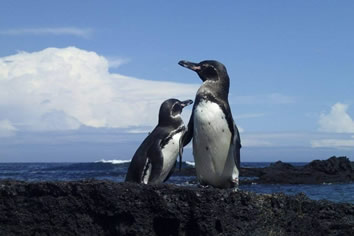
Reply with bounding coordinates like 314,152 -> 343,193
0,180 -> 354,236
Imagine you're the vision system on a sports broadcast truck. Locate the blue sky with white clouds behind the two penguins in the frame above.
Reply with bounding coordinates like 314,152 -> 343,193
0,1 -> 354,162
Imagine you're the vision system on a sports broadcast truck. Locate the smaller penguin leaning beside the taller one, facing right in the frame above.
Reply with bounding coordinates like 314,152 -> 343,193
125,98 -> 193,184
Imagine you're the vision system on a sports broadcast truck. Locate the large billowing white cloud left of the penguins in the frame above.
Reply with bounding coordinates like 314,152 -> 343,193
0,47 -> 199,134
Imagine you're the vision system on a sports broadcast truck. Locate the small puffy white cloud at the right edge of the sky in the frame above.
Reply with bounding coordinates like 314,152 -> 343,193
318,103 -> 354,133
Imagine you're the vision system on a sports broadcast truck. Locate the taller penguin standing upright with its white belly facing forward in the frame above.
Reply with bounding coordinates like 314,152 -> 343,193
178,61 -> 241,188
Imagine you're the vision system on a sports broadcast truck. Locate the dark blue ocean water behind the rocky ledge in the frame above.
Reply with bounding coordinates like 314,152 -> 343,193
0,160 -> 354,204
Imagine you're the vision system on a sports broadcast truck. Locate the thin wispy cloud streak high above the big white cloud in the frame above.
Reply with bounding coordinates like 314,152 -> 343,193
0,27 -> 93,38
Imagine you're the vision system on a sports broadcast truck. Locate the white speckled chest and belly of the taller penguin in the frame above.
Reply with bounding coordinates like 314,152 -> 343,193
193,100 -> 235,185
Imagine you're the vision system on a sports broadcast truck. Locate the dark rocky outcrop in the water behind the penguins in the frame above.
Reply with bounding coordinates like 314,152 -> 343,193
241,156 -> 354,184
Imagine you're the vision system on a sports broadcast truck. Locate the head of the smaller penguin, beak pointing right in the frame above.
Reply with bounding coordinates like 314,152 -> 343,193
159,98 -> 193,125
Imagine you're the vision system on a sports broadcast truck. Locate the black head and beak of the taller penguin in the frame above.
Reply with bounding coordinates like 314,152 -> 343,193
178,60 -> 229,84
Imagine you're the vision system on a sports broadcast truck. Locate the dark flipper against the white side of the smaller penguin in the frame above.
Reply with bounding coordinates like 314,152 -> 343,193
148,139 -> 163,183
